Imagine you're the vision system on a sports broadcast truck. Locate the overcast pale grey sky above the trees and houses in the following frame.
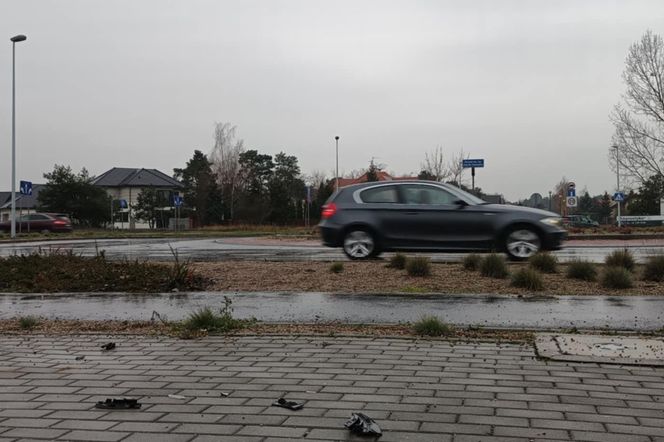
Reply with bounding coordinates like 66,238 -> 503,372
0,0 -> 664,200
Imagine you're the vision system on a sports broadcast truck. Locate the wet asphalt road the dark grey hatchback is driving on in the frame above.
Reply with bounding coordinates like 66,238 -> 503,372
0,238 -> 664,262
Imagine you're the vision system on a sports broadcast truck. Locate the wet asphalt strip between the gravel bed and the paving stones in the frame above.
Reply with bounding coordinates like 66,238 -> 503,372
0,293 -> 664,330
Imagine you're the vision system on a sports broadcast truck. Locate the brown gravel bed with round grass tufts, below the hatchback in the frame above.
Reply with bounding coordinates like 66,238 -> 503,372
192,261 -> 664,295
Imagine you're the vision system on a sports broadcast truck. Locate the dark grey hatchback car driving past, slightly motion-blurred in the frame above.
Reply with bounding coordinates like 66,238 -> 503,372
318,181 -> 566,260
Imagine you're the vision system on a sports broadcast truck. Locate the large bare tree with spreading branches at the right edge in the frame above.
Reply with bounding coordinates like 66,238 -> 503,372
609,31 -> 664,184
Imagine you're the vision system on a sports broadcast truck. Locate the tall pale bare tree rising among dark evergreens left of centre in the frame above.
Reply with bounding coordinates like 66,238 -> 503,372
210,123 -> 244,219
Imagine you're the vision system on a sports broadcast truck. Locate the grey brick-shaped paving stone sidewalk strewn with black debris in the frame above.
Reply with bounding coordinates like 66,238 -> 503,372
0,335 -> 664,442
